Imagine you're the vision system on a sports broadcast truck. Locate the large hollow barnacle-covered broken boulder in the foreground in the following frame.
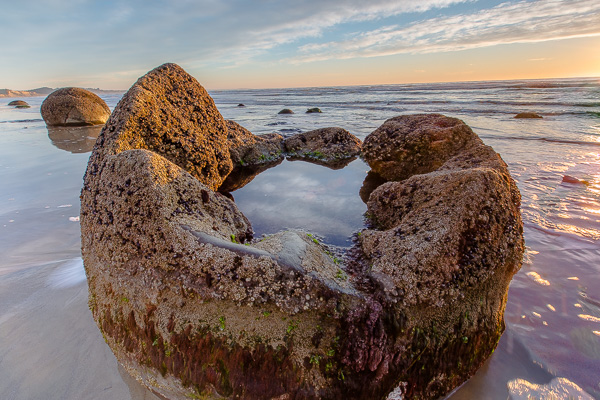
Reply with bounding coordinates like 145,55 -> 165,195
81,64 -> 523,399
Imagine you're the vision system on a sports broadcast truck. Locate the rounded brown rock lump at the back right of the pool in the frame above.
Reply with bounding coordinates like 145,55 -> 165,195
362,114 -> 475,180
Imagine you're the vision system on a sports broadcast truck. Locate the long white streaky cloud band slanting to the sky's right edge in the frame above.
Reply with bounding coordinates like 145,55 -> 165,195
287,0 -> 600,63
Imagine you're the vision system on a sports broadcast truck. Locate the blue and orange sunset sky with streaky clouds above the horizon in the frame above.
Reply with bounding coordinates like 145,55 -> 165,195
0,0 -> 600,90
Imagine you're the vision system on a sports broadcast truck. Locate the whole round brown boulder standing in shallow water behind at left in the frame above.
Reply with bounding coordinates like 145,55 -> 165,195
41,87 -> 110,126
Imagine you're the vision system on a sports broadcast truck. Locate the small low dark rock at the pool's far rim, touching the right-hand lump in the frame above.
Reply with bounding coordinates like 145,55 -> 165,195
284,128 -> 361,164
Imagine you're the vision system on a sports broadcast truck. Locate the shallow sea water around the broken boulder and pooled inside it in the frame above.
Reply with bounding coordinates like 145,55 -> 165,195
0,78 -> 600,400
